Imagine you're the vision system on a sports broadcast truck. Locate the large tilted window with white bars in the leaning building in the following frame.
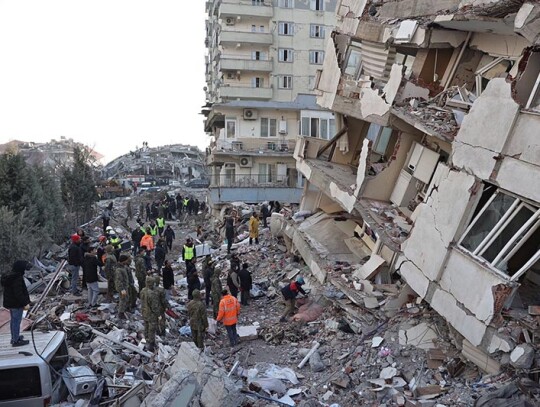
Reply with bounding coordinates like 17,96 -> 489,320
460,184 -> 540,280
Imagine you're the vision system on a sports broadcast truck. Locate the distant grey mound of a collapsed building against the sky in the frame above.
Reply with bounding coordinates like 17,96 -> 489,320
102,143 -> 206,183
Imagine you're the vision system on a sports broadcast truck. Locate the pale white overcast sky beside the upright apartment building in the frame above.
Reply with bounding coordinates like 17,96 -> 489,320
0,0 -> 208,161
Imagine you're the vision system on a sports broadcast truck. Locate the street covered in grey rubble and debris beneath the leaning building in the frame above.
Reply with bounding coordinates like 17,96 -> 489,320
4,191 -> 540,407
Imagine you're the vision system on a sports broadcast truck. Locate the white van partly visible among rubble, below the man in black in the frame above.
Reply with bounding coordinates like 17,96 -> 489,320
0,331 -> 69,407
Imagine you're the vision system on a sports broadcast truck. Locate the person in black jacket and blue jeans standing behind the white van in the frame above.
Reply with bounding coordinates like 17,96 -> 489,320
0,260 -> 31,346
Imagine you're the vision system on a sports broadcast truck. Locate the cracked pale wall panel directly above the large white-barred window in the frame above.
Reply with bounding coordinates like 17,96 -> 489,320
452,78 -> 519,180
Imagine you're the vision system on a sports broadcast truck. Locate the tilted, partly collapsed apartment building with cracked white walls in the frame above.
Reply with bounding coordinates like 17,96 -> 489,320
274,0 -> 540,370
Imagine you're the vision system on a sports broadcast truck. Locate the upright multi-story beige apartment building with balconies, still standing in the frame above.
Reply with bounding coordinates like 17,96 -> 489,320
203,0 -> 337,215
